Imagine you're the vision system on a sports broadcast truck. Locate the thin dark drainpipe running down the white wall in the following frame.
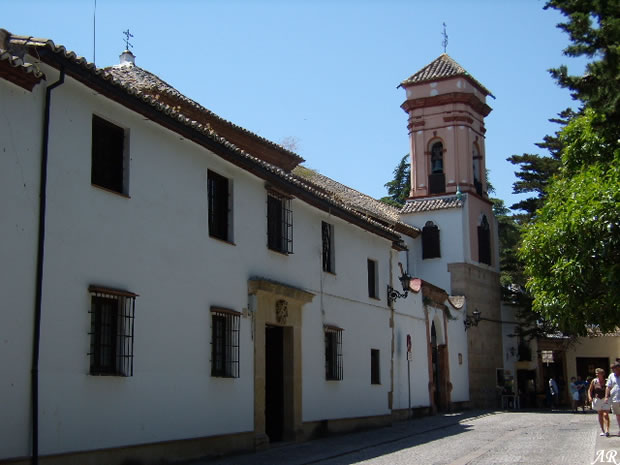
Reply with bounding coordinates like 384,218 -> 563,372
31,68 -> 65,465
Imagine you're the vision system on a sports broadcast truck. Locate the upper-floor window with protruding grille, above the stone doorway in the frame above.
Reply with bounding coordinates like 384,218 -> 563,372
267,192 -> 293,254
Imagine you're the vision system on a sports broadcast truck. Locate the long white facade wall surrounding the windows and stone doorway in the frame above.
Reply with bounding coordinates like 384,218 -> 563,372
0,62 -> 402,458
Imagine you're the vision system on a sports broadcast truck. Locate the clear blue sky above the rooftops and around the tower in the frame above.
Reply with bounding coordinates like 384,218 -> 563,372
0,0 -> 584,205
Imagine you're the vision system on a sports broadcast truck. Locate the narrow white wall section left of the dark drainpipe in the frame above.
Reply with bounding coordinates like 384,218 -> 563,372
0,71 -> 45,459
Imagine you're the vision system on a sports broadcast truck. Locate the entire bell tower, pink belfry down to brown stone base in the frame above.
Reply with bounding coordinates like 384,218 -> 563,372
399,53 -> 503,408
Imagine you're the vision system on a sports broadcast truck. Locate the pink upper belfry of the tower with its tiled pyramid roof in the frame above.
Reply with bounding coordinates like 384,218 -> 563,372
400,53 -> 492,198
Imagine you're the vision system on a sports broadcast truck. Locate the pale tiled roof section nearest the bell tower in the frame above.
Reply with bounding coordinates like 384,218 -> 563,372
293,166 -> 420,237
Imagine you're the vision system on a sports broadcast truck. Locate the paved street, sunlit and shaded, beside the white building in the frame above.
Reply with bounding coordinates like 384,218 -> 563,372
186,411 -> 620,465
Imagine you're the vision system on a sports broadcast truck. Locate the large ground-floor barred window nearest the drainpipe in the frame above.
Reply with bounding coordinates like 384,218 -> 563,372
88,286 -> 137,376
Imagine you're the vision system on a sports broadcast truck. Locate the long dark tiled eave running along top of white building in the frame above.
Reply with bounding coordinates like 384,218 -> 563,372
0,29 -> 411,240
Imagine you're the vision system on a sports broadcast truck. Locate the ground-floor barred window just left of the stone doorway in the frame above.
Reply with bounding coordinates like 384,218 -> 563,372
211,307 -> 240,378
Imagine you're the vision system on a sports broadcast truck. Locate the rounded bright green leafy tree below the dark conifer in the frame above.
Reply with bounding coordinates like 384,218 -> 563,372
520,136 -> 620,334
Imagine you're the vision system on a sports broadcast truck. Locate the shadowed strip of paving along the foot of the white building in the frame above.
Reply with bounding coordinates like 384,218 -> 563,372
183,410 -> 494,465
